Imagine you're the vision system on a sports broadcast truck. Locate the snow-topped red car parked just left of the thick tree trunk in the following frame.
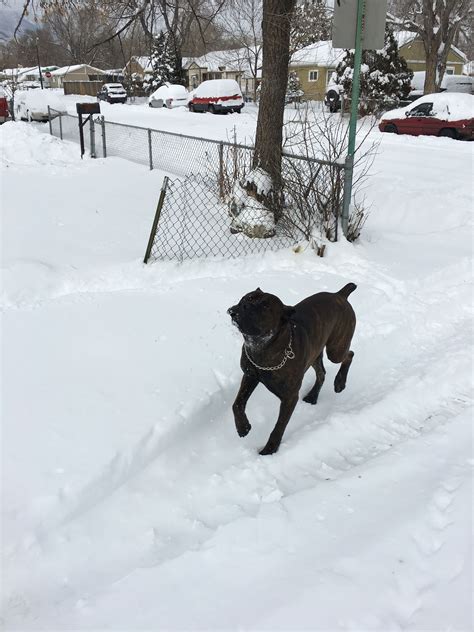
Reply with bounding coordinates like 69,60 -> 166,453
188,79 -> 244,114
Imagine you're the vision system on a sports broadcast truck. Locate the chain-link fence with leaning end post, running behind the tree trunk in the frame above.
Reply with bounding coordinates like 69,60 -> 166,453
49,109 -> 344,262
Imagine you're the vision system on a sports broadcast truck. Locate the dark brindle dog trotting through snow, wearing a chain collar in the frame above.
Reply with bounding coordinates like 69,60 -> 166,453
227,283 -> 357,454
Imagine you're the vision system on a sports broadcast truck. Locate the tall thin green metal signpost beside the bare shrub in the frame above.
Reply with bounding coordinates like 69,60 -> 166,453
342,0 -> 365,235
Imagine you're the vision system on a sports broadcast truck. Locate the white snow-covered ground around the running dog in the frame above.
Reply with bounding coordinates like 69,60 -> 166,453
0,119 -> 473,632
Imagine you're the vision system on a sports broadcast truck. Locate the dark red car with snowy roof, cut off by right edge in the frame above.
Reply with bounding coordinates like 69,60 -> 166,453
379,92 -> 474,140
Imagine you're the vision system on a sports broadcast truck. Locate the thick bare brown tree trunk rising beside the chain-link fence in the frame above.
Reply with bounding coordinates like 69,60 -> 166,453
253,0 -> 295,219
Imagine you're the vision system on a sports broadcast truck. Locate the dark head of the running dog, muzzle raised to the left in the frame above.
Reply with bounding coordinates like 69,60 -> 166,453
227,288 -> 295,337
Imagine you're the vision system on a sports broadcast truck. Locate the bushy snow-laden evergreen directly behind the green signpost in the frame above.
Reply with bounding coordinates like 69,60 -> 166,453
333,27 -> 413,115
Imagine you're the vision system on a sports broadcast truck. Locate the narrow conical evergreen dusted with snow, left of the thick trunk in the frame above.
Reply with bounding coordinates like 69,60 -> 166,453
143,31 -> 184,92
